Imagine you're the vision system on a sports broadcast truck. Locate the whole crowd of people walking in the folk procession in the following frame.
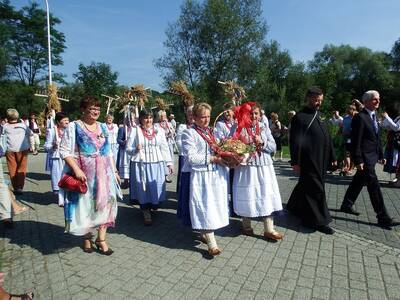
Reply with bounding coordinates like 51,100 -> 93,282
0,87 -> 400,256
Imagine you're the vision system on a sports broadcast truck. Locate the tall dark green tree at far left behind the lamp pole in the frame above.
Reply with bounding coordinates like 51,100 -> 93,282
0,0 -> 65,85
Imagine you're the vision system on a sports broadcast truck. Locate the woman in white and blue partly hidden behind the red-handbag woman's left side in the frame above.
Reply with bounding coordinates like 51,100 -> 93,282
44,112 -> 69,206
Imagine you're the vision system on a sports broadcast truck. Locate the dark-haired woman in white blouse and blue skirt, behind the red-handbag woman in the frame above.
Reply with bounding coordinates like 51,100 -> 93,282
126,110 -> 173,225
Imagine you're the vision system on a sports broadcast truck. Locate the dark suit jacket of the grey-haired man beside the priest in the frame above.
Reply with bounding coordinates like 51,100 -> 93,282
351,109 -> 383,165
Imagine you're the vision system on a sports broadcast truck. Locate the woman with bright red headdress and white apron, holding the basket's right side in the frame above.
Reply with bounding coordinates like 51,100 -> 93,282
233,102 -> 283,240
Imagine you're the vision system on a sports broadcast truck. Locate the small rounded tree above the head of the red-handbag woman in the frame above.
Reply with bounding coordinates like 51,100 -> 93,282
73,62 -> 118,99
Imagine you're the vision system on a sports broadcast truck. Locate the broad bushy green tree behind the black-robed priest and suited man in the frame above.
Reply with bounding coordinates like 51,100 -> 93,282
309,45 -> 393,112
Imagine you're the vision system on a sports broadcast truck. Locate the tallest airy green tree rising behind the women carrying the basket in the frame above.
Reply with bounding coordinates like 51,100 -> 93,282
156,0 -> 267,110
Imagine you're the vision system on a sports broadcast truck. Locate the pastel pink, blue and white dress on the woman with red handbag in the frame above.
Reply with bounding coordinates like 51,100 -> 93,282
60,121 -> 122,235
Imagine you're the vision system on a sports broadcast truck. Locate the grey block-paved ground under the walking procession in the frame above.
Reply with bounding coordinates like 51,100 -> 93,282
0,154 -> 400,300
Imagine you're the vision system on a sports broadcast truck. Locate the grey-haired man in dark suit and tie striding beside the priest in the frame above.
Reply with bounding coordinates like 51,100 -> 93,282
340,91 -> 398,229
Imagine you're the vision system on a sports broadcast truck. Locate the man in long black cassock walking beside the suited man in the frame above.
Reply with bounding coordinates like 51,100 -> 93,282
287,87 -> 337,234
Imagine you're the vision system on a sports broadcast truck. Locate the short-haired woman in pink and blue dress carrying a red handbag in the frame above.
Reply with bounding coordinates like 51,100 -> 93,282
60,97 -> 122,255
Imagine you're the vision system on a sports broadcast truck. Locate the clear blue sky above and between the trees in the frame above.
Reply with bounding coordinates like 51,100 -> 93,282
11,0 -> 400,90
